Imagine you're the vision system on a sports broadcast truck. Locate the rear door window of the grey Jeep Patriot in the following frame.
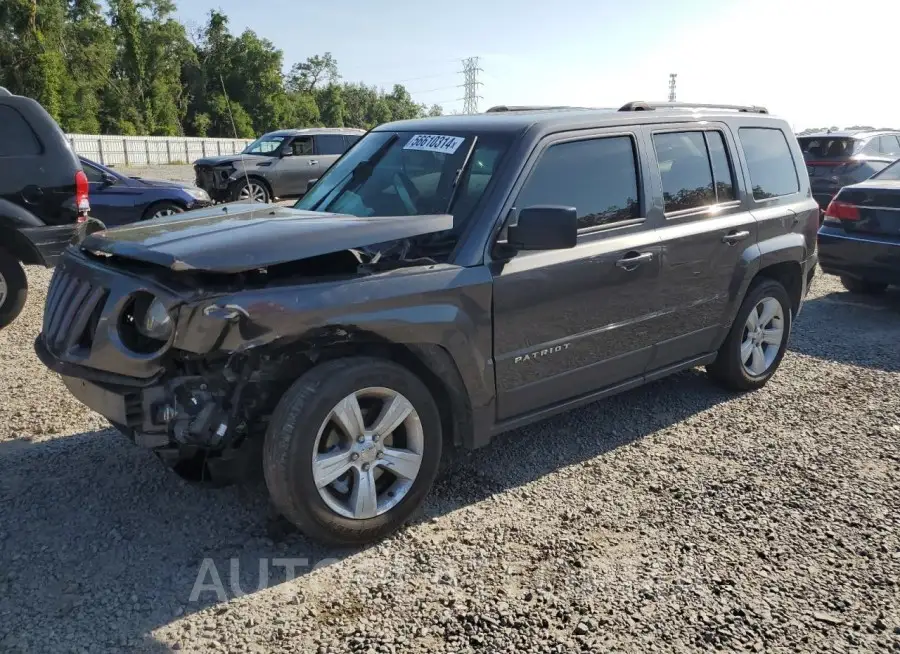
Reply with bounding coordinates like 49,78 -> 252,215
653,131 -> 734,213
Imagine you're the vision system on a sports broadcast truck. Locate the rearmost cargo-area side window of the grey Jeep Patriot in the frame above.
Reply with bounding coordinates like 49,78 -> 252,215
738,127 -> 800,200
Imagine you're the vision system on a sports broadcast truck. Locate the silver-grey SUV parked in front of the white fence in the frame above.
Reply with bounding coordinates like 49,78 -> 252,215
194,127 -> 365,202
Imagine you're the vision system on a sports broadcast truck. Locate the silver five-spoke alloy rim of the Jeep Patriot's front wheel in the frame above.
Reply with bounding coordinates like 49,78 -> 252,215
312,387 -> 425,520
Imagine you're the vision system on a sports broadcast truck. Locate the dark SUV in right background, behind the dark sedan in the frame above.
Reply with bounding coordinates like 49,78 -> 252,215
797,131 -> 900,211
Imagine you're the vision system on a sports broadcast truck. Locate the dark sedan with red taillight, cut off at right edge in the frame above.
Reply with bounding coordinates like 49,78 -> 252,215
819,161 -> 900,293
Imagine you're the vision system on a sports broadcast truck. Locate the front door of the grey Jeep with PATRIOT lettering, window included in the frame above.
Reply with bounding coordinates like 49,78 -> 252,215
494,130 -> 661,420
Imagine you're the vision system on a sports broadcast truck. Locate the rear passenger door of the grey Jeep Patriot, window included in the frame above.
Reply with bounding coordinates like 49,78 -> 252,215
647,123 -> 758,370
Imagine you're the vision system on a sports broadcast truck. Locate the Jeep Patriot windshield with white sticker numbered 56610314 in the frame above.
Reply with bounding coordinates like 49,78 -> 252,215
294,132 -> 507,232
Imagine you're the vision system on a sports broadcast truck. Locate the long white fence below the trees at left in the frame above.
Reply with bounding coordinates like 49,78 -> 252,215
66,134 -> 252,166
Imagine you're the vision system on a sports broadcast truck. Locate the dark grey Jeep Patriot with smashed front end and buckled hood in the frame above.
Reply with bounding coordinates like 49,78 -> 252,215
35,103 -> 818,544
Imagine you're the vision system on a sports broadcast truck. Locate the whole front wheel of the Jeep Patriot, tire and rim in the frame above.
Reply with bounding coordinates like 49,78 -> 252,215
263,357 -> 443,546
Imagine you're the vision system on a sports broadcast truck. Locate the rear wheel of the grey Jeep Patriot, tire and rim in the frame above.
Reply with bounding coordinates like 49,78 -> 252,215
706,278 -> 793,391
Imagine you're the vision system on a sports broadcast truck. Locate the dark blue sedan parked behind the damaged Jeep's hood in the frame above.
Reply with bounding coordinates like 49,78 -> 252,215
79,157 -> 212,227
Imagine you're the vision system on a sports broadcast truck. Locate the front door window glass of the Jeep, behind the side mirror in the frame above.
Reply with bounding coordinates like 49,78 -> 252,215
516,136 -> 641,229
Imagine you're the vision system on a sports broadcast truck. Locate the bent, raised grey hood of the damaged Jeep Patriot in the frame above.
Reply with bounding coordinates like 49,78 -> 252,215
80,204 -> 453,273
